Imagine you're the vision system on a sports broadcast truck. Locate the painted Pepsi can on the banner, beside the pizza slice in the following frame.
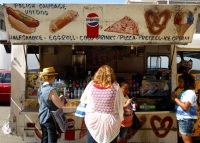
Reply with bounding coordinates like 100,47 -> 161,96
86,13 -> 99,38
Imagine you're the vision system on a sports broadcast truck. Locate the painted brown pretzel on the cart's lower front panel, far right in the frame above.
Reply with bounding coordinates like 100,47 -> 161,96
150,115 -> 173,138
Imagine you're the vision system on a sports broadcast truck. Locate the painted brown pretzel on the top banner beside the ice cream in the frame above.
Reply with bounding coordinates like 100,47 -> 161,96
144,9 -> 171,35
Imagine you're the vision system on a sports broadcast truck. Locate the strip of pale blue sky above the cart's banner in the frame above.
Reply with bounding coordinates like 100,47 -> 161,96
0,0 -> 126,4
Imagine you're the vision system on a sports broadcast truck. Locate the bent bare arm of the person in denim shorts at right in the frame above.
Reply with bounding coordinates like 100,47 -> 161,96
171,92 -> 191,111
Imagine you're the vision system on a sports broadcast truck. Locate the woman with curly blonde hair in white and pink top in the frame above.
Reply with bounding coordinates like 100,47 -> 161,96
81,65 -> 124,143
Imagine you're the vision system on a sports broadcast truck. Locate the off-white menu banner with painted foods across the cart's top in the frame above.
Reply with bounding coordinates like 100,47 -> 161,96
4,3 -> 199,44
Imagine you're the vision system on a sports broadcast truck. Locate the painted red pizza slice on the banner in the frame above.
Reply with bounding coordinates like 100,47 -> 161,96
104,16 -> 139,35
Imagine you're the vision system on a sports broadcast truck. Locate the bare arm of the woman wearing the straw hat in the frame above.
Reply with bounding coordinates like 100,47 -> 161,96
49,89 -> 65,108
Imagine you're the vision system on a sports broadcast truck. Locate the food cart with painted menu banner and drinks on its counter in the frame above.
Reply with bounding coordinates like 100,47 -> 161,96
4,3 -> 199,143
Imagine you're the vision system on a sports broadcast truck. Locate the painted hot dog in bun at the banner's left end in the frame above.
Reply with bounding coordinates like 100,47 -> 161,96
6,7 -> 39,34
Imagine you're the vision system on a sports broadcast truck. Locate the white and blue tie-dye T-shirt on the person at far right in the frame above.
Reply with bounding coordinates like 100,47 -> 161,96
175,90 -> 197,120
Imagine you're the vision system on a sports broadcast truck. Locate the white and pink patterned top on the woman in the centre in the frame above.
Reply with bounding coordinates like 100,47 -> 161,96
81,82 -> 124,143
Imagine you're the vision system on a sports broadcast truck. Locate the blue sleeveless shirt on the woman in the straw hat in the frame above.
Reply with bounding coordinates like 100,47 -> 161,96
38,84 -> 58,124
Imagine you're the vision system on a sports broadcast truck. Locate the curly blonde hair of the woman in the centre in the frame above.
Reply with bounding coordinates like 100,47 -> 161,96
94,65 -> 117,88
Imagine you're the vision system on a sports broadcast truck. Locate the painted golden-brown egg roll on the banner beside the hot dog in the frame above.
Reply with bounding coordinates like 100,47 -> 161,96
49,10 -> 78,33
